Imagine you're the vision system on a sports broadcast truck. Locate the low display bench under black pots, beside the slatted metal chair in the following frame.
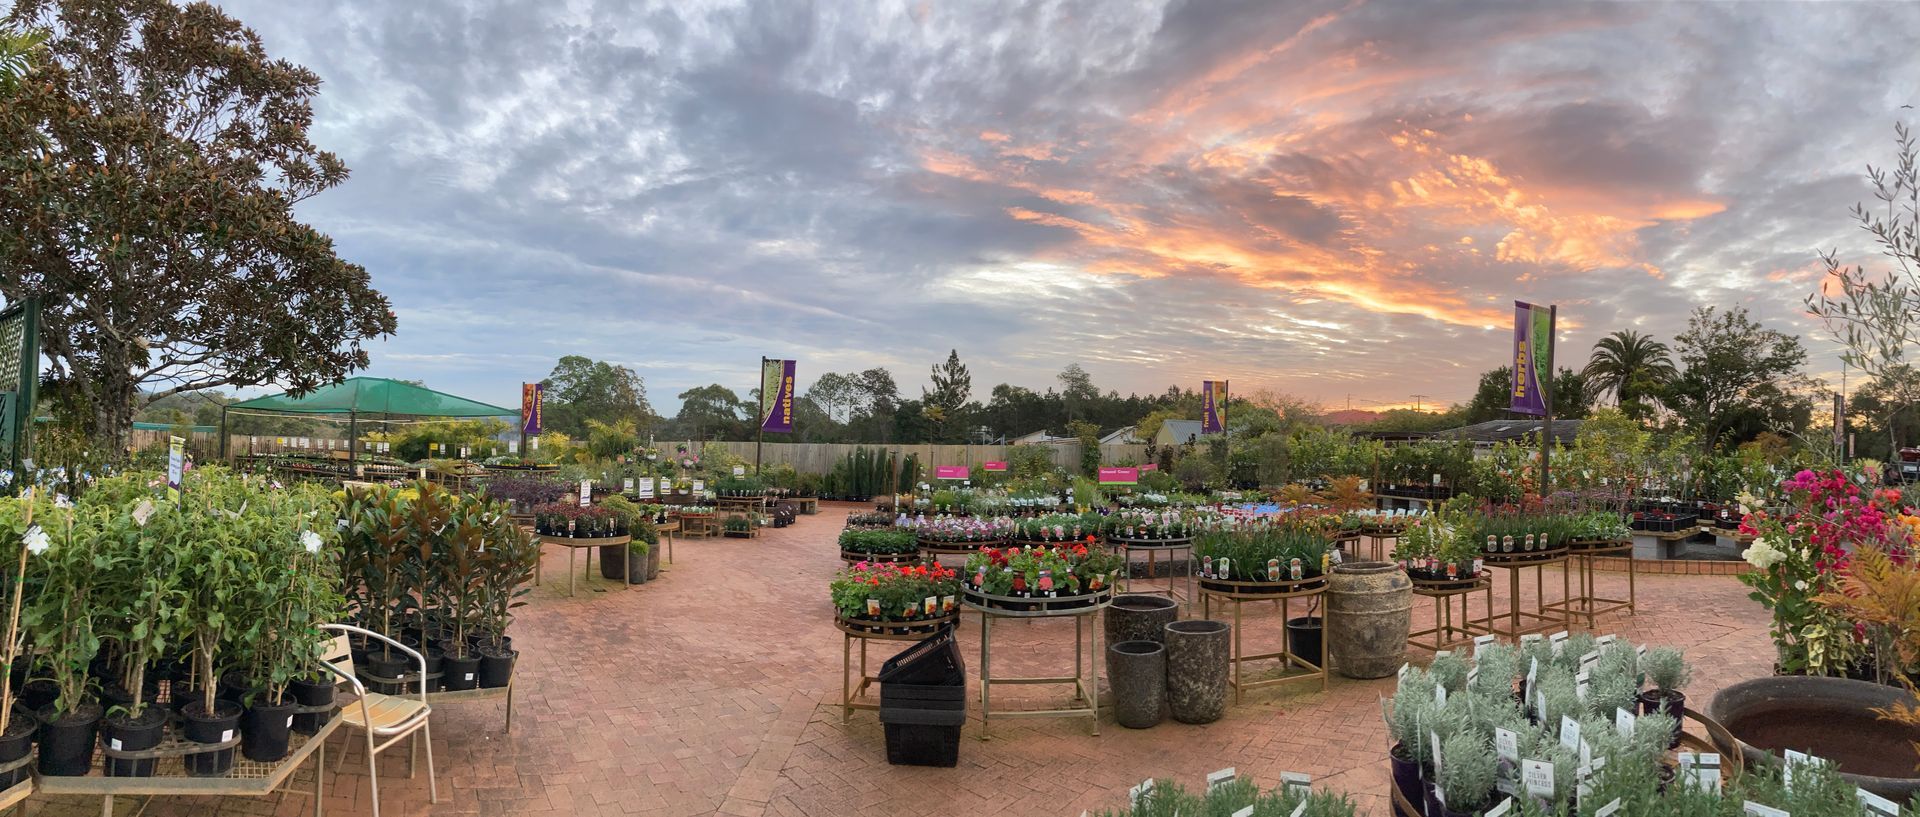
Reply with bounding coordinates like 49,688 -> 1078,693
34,710 -> 342,817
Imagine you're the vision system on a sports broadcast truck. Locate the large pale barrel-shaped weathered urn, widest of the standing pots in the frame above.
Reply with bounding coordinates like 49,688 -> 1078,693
1327,562 -> 1413,679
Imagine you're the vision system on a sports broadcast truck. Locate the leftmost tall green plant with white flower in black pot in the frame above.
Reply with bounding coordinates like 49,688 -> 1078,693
25,508 -> 102,777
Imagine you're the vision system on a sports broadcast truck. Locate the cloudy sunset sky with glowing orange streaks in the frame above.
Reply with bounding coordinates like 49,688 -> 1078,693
221,0 -> 1920,414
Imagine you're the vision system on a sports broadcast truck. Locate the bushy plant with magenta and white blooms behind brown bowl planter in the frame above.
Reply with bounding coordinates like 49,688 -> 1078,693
1740,470 -> 1916,675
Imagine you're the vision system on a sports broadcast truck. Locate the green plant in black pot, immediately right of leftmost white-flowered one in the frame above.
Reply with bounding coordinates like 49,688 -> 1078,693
98,499 -> 180,777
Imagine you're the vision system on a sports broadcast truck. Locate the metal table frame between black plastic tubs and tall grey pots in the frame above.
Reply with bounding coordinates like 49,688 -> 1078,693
960,585 -> 1114,740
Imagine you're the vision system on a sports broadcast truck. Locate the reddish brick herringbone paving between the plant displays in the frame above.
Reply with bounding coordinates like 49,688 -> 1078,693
31,504 -> 1772,817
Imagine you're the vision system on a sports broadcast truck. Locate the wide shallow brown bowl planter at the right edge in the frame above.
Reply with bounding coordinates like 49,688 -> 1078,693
1707,675 -> 1920,804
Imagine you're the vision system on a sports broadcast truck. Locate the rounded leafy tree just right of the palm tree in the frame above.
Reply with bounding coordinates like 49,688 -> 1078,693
1661,307 -> 1812,451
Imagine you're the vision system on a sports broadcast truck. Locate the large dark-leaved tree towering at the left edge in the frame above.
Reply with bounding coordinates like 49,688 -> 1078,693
0,0 -> 394,453
